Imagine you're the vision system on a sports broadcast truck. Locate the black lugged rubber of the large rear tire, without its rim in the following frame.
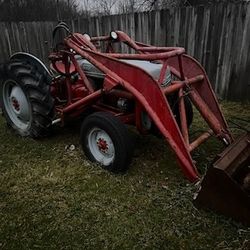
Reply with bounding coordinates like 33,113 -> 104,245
0,59 -> 54,138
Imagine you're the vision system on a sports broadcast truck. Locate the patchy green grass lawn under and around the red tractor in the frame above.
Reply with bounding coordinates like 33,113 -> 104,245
0,103 -> 250,250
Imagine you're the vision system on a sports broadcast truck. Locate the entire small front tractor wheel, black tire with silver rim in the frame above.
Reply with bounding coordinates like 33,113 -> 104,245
80,112 -> 132,173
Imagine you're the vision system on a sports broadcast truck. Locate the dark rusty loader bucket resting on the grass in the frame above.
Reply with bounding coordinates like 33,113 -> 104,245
194,133 -> 250,226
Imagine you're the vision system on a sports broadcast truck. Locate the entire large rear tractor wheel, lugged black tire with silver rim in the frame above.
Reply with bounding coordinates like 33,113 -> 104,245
0,59 -> 54,138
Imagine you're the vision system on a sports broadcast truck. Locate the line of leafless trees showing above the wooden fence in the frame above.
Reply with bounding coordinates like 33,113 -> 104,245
0,0 -> 244,21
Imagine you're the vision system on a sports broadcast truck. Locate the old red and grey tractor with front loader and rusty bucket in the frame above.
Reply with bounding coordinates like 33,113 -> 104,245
0,23 -> 250,225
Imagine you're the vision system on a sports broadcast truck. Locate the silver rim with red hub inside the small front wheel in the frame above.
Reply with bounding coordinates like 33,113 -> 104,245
87,127 -> 115,166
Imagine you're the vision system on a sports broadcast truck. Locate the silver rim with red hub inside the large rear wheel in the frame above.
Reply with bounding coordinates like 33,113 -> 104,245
2,80 -> 32,130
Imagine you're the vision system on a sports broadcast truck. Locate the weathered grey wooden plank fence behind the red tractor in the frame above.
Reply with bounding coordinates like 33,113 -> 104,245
0,3 -> 250,100
